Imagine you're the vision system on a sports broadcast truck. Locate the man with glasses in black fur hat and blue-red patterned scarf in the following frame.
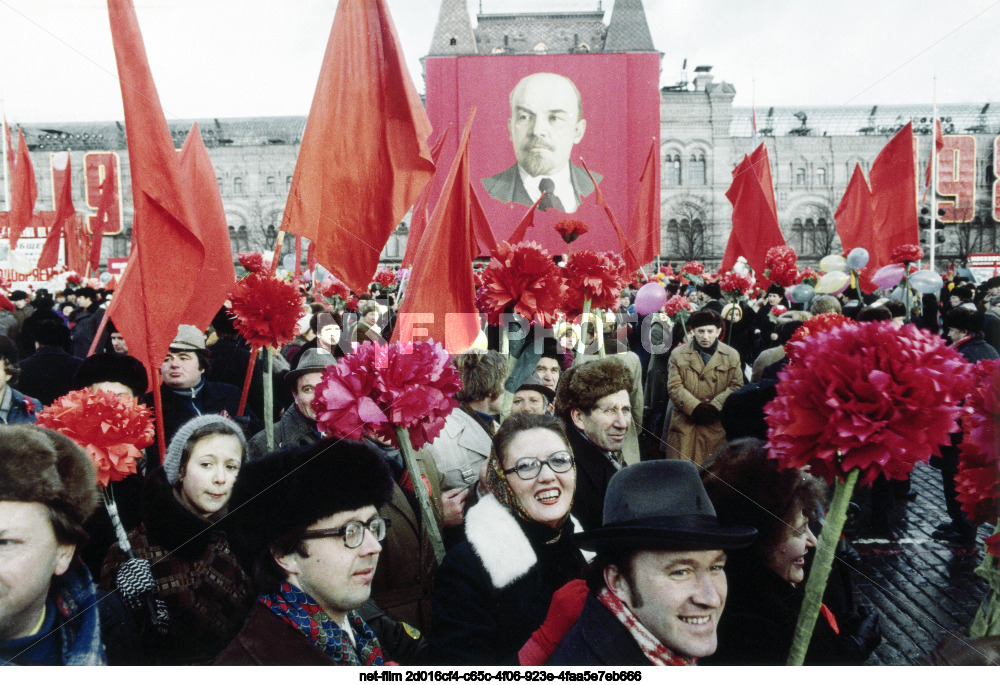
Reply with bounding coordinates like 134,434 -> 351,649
216,439 -> 423,666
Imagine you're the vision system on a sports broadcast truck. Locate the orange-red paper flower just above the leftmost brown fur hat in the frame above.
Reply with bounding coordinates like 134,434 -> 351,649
35,390 -> 154,487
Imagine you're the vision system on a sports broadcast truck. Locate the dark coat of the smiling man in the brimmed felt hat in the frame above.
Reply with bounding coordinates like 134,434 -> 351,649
546,594 -> 653,666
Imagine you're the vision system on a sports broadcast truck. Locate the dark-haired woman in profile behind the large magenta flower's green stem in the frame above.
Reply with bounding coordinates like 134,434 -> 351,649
699,438 -> 881,665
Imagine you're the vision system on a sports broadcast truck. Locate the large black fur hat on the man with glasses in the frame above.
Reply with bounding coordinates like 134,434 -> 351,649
229,438 -> 393,569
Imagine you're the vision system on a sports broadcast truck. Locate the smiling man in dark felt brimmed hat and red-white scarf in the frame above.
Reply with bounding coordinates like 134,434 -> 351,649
549,460 -> 757,666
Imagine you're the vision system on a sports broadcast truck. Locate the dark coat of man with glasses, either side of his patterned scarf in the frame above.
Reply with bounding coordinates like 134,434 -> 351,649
215,600 -> 427,666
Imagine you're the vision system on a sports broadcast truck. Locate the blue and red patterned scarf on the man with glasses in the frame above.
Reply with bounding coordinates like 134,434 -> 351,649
257,583 -> 385,666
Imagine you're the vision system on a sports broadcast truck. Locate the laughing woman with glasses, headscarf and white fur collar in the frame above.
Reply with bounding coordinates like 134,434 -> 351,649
430,414 -> 585,665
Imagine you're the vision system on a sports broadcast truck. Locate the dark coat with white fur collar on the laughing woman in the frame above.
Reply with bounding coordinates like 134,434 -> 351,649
430,495 -> 585,665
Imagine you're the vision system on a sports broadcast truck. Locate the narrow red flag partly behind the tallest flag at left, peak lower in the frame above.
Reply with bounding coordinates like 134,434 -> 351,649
180,122 -> 236,330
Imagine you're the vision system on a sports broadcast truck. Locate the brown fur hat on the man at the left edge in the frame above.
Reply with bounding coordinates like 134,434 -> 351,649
0,424 -> 99,526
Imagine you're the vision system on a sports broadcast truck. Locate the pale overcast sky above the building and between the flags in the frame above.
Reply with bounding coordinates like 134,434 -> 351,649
0,0 -> 1000,122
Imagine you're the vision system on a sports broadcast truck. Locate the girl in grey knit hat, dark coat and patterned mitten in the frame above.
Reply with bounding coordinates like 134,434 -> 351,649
101,414 -> 254,665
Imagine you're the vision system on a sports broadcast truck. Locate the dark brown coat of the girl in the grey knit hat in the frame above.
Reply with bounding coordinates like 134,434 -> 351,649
101,469 -> 255,665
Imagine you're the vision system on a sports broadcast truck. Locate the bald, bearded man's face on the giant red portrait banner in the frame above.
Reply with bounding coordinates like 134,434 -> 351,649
508,73 -> 587,176
